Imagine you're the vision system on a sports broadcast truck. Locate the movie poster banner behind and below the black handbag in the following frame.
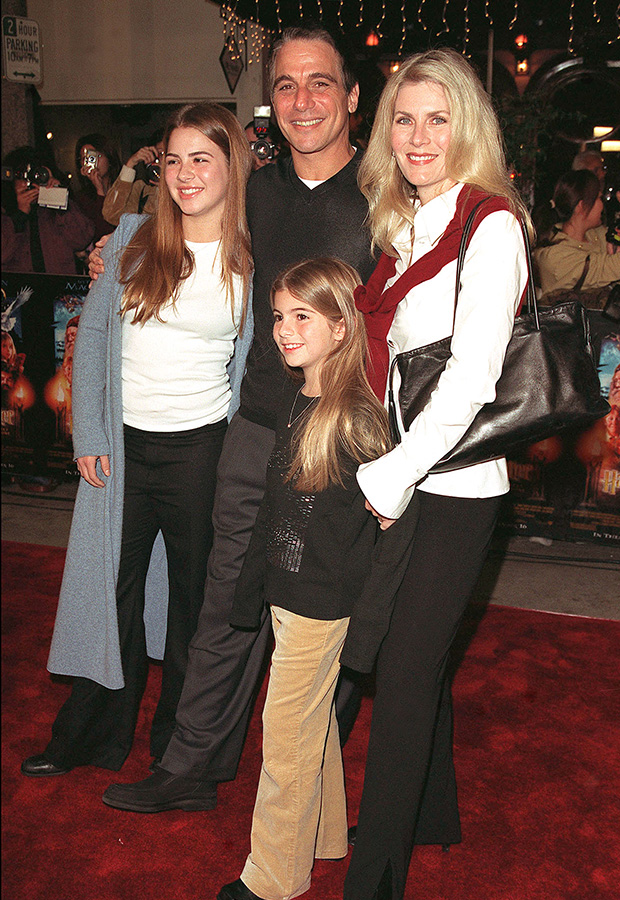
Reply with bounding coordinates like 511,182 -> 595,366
502,310 -> 620,544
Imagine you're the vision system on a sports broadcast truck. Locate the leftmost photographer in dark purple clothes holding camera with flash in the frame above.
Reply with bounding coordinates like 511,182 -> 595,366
2,147 -> 95,275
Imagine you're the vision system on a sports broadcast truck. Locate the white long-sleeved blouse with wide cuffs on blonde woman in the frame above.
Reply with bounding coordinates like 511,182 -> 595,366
357,184 -> 527,518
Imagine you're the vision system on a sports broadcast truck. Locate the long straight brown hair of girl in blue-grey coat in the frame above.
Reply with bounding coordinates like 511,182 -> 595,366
120,103 -> 252,329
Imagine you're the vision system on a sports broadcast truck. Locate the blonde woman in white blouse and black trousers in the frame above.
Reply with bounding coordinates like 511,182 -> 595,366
342,50 -> 527,900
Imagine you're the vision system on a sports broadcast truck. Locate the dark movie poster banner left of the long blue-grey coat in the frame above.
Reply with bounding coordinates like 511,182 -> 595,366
2,273 -> 88,477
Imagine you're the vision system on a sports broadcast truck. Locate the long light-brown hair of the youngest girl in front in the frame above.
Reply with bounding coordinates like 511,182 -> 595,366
271,257 -> 391,493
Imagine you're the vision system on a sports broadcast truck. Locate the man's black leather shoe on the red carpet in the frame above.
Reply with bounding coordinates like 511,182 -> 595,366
103,766 -> 217,813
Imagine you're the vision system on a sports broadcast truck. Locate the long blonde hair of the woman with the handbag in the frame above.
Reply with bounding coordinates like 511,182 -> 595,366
358,49 -> 533,256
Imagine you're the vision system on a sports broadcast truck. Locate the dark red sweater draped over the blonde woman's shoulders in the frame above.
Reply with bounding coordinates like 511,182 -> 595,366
355,186 -> 510,402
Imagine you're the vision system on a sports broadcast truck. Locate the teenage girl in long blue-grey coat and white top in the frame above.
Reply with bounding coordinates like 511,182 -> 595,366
22,103 -> 251,776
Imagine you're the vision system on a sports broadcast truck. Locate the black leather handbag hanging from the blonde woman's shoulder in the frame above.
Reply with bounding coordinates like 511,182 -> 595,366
388,200 -> 610,474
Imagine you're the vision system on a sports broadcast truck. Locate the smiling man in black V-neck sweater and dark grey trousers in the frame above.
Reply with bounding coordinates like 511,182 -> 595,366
72,29 -> 374,812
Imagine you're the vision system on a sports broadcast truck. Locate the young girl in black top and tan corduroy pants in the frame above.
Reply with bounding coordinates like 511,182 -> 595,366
218,258 -> 389,900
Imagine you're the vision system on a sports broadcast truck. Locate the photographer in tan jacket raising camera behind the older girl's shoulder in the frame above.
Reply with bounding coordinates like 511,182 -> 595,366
103,128 -> 164,225
